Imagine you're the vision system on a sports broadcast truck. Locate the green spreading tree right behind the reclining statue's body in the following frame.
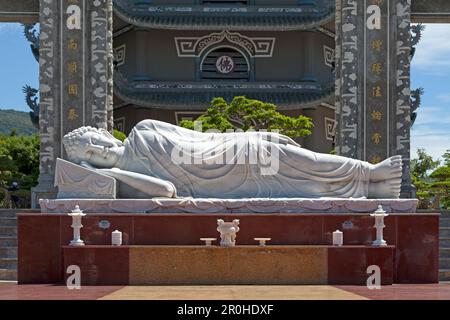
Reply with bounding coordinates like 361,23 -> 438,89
180,96 -> 314,138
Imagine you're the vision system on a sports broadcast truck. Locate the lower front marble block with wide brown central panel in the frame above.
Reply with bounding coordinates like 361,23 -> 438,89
63,245 -> 394,285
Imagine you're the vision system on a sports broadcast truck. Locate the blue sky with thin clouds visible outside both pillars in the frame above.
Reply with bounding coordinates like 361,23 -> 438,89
0,23 -> 450,158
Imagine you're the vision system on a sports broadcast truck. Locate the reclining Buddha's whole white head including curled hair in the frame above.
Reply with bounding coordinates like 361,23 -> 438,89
63,127 -> 124,168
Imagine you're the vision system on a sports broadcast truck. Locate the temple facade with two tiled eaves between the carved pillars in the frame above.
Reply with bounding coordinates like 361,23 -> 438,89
113,0 -> 336,153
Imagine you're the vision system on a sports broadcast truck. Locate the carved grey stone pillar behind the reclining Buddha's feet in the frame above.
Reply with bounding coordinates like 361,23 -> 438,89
336,0 -> 412,196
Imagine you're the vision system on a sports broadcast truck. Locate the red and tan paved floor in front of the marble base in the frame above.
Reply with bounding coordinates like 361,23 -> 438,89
0,283 -> 450,300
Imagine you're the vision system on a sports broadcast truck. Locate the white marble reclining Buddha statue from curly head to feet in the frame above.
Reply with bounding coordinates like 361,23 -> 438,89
63,120 -> 402,199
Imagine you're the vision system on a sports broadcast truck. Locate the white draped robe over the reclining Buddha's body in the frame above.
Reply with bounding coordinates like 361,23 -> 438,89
116,120 -> 371,198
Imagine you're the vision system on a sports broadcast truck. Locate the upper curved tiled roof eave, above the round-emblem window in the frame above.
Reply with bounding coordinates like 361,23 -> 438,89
114,0 -> 335,31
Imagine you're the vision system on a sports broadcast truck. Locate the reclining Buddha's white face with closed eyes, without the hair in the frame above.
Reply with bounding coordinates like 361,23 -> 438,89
80,132 -> 124,168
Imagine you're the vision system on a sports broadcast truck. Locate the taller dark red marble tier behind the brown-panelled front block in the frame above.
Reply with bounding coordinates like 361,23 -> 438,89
18,213 -> 439,284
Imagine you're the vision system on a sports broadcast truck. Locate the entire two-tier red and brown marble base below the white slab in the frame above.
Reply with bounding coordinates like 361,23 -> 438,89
18,211 -> 439,285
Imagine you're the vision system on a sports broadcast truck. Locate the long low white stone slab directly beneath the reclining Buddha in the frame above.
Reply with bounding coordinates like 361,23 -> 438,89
40,198 -> 418,214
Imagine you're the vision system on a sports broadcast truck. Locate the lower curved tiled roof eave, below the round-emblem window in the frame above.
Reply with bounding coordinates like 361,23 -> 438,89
114,71 -> 335,111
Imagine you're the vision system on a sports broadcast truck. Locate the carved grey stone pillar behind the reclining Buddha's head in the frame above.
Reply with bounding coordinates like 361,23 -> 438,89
32,0 -> 113,208
